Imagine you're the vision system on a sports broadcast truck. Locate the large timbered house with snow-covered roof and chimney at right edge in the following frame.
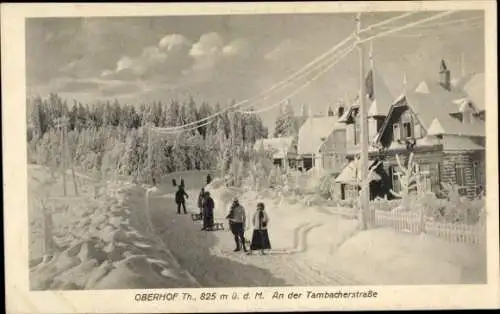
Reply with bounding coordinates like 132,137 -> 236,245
371,61 -> 485,196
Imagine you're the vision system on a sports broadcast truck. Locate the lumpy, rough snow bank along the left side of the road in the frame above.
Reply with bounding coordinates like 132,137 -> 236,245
30,168 -> 194,290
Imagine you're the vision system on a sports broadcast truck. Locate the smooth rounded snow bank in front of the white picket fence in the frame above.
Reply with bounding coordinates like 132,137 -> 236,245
331,229 -> 485,285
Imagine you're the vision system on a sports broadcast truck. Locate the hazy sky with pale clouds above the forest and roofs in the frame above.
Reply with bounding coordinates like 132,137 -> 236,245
26,11 -> 484,129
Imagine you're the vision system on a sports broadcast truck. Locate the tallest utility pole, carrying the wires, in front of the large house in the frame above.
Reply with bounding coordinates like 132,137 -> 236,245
356,13 -> 370,229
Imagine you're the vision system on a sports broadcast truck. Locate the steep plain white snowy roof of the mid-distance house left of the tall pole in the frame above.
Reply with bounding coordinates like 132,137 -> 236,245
298,116 -> 345,155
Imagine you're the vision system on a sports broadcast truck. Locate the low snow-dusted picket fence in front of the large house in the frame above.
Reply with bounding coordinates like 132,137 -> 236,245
374,210 -> 486,245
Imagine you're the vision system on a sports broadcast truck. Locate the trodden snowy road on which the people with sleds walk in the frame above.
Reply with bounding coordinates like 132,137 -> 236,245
139,186 -> 357,287
